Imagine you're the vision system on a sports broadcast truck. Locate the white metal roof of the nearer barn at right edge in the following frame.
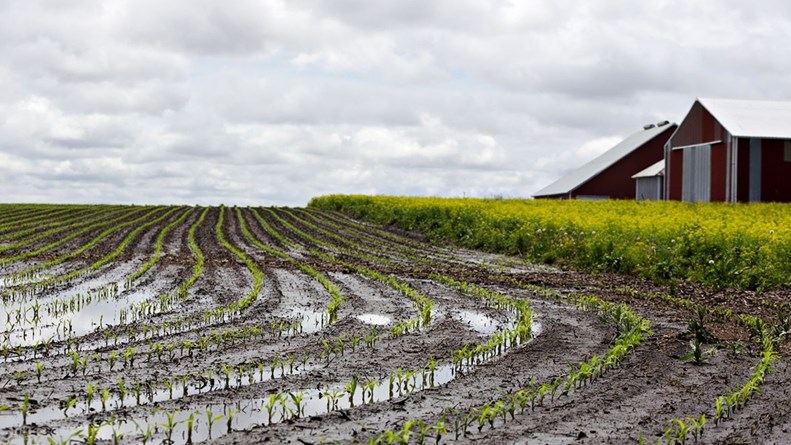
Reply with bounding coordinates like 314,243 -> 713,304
698,99 -> 791,139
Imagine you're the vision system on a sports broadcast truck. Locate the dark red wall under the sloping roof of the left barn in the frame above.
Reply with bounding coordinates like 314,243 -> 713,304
572,125 -> 676,199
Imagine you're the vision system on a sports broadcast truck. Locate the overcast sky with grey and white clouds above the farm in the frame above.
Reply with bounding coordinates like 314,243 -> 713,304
0,0 -> 791,206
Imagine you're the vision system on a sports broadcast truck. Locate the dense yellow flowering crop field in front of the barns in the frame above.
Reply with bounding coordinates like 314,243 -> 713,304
309,195 -> 791,290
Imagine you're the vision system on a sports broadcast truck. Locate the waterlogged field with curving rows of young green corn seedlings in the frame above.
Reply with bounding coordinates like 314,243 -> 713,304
0,202 -> 791,444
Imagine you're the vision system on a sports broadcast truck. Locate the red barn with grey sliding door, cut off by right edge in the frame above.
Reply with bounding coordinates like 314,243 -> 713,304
664,99 -> 791,202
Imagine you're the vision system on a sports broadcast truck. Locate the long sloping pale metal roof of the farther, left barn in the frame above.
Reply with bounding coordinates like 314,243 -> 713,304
533,124 -> 675,197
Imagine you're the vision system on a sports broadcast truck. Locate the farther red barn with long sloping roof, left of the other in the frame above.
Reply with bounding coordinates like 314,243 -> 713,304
533,121 -> 676,199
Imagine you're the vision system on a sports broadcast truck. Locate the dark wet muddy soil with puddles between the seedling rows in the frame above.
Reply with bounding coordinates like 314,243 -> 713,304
0,208 -> 791,444
